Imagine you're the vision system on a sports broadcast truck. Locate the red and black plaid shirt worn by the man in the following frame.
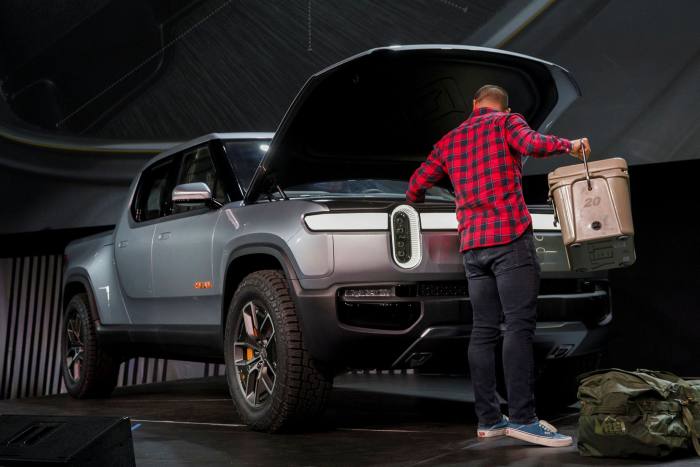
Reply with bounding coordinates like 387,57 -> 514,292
406,107 -> 571,251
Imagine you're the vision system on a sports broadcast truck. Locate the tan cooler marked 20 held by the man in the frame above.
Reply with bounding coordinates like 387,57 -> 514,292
547,157 -> 636,271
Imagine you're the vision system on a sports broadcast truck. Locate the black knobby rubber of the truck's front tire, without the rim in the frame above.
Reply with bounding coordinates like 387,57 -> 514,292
224,270 -> 333,433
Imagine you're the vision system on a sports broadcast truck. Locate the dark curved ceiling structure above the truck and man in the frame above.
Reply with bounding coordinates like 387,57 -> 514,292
0,0 -> 700,234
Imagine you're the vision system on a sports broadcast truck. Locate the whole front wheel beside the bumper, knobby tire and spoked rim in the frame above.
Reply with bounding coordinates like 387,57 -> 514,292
224,270 -> 333,432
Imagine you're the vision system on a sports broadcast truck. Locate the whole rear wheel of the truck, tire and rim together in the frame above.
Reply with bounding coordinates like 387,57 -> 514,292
61,293 -> 120,399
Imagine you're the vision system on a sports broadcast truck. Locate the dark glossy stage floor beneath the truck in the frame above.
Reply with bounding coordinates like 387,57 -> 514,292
0,374 -> 700,466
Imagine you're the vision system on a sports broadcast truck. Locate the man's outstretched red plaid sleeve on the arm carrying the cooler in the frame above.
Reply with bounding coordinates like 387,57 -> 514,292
506,114 -> 574,157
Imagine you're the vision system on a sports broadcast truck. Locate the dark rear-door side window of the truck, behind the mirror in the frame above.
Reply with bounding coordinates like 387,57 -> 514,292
131,159 -> 173,222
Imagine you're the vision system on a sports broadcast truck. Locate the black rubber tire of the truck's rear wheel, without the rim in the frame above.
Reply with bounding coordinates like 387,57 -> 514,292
61,293 -> 121,399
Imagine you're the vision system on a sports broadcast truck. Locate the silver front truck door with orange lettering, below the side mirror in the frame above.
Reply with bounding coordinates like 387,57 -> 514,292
153,145 -> 228,325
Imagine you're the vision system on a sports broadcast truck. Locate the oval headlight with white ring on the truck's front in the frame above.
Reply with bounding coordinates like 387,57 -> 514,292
389,204 -> 423,269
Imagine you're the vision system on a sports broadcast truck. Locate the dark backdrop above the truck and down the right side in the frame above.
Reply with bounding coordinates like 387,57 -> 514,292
0,0 -> 700,376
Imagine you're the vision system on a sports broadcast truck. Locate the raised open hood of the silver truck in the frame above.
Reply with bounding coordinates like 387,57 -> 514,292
246,45 -> 580,202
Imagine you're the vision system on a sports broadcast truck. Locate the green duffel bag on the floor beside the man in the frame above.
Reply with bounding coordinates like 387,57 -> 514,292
578,369 -> 700,457
